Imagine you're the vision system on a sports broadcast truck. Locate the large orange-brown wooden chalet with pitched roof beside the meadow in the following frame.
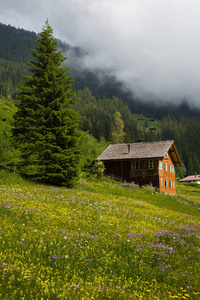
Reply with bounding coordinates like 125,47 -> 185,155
98,140 -> 182,194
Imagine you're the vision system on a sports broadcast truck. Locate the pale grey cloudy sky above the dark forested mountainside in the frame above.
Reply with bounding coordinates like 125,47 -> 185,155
0,0 -> 200,107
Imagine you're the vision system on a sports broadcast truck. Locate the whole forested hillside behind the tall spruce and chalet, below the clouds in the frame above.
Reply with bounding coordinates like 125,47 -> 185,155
0,24 -> 200,176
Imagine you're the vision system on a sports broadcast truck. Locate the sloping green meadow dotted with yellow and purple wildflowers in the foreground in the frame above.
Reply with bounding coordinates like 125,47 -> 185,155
0,172 -> 200,300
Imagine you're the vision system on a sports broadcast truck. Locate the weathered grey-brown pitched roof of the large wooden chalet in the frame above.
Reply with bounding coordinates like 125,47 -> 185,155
98,141 -> 181,164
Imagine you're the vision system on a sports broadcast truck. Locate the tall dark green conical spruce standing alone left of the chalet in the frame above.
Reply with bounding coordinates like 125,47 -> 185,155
13,20 -> 80,187
